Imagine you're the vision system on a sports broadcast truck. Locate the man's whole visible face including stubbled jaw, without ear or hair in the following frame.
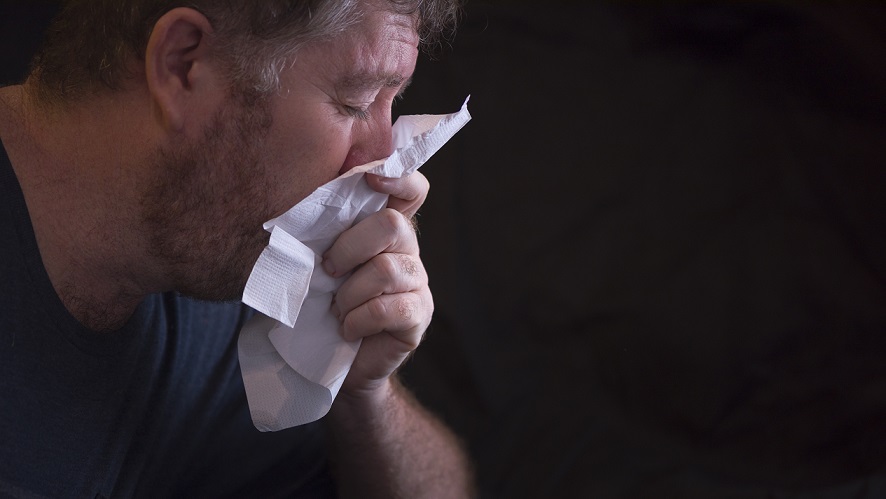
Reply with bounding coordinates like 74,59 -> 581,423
143,3 -> 418,300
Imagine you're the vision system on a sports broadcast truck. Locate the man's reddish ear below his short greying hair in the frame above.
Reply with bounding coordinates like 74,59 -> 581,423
145,7 -> 217,132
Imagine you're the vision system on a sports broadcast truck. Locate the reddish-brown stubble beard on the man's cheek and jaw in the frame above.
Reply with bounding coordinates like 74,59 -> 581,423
142,91 -> 275,301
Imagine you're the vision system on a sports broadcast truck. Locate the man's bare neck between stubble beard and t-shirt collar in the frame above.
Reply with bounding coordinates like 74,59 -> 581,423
0,83 -> 164,331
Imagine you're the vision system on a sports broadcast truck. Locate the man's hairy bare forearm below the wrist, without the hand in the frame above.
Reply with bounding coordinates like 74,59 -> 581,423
326,380 -> 473,498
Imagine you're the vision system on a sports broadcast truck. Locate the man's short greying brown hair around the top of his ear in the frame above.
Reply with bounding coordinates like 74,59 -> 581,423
31,0 -> 459,103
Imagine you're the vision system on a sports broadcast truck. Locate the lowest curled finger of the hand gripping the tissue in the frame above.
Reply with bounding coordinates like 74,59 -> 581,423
342,288 -> 433,344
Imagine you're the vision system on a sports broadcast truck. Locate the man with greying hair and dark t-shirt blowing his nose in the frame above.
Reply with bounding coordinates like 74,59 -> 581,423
0,0 -> 470,497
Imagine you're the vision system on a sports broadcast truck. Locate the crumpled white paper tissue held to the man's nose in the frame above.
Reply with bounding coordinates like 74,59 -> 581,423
238,100 -> 471,431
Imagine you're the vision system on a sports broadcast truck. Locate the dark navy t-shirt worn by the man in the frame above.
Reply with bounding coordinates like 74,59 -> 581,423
0,144 -> 331,498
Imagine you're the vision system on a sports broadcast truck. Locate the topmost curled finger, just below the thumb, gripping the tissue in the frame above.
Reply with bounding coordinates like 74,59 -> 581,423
323,208 -> 419,277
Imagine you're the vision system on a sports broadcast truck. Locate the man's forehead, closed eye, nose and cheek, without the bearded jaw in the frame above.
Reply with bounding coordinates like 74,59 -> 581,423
256,1 -> 418,216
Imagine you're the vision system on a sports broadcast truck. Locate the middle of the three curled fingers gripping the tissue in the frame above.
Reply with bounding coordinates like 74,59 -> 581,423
334,253 -> 428,318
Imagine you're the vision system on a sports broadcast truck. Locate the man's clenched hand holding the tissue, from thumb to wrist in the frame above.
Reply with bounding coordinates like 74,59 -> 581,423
323,172 -> 434,395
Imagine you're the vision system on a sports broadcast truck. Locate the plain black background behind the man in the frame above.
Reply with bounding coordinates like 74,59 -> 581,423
0,0 -> 886,499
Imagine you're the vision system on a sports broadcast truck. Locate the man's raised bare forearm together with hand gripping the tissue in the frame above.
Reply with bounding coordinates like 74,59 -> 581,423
324,173 -> 473,498
